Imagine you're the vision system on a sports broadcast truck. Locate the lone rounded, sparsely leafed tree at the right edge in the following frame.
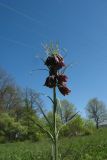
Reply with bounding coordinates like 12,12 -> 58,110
86,98 -> 107,129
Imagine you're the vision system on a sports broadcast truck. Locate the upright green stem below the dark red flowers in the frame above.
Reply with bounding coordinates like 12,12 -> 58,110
53,87 -> 58,160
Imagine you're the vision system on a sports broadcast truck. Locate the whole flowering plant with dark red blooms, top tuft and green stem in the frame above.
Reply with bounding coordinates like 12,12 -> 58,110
41,45 -> 71,160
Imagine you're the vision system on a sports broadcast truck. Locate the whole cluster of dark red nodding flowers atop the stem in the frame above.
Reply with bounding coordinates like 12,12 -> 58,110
44,54 -> 71,96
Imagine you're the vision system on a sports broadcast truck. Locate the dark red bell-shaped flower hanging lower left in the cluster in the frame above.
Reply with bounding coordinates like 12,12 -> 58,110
44,75 -> 56,88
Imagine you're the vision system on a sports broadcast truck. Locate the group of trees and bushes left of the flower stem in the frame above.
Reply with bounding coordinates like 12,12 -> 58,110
0,69 -> 42,142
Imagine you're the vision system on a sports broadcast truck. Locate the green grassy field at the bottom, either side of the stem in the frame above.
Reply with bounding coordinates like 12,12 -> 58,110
0,129 -> 107,160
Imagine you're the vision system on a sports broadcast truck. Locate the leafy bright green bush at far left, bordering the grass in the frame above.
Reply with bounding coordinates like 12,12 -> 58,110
0,113 -> 26,141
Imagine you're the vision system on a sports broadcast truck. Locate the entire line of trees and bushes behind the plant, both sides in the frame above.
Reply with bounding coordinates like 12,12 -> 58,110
0,69 -> 105,142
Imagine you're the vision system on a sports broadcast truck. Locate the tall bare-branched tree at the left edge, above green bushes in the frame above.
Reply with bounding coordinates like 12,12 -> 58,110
0,68 -> 21,112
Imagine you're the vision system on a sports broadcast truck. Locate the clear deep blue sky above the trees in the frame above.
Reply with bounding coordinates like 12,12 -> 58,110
0,0 -> 107,116
